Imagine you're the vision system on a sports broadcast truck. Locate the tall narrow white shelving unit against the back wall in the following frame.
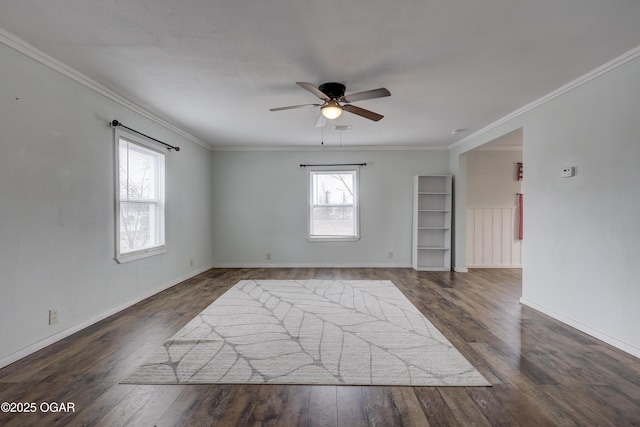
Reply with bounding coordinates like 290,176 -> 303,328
412,175 -> 451,271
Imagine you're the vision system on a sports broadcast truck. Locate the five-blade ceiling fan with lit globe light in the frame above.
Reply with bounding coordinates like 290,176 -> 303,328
269,82 -> 391,127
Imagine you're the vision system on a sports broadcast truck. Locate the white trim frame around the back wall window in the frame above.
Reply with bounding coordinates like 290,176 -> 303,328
307,166 -> 361,242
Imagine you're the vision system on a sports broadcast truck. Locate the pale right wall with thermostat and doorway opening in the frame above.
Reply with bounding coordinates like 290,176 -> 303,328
451,52 -> 640,356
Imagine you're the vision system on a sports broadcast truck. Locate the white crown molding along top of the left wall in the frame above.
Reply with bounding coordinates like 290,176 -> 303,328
0,28 -> 211,150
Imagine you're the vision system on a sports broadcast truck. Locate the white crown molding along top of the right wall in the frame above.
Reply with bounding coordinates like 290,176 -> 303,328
448,46 -> 640,150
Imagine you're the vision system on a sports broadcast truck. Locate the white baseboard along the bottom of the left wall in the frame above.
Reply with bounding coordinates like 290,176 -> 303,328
0,267 -> 212,368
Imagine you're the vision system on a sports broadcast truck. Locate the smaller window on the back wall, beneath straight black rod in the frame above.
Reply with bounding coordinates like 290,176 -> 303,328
309,169 -> 360,241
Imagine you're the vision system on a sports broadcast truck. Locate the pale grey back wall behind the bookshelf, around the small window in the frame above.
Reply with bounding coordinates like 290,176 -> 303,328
212,150 -> 448,267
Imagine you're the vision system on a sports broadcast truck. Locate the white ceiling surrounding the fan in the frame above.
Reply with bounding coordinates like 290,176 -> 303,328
0,0 -> 640,148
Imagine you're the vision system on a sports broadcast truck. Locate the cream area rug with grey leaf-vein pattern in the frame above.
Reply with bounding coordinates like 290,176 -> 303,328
123,280 -> 490,386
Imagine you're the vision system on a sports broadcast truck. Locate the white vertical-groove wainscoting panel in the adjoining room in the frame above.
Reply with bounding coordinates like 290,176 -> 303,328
467,206 -> 522,268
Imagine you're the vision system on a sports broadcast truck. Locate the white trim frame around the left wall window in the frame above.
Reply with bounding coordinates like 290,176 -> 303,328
114,128 -> 167,264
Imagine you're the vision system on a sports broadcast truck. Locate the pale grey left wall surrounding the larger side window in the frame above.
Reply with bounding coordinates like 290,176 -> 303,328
0,44 -> 212,366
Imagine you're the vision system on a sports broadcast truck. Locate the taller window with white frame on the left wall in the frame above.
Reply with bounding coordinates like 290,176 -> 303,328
116,130 -> 166,262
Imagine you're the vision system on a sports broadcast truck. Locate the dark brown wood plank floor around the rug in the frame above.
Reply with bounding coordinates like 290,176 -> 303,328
0,269 -> 640,427
